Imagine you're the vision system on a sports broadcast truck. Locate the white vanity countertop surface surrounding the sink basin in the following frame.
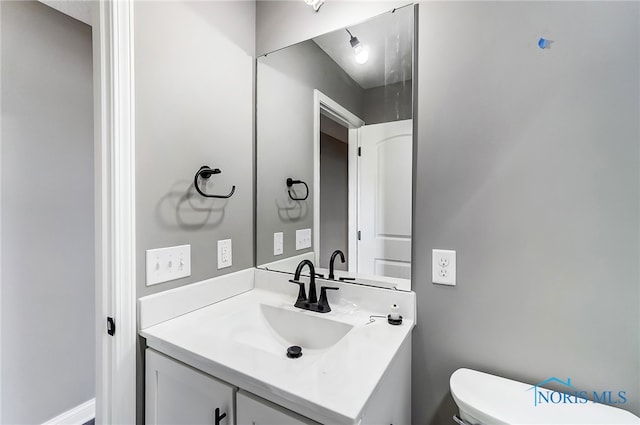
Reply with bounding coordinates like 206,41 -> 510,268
140,272 -> 415,424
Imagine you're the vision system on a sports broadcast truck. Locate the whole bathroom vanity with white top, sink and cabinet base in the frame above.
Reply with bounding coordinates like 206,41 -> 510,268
139,269 -> 416,424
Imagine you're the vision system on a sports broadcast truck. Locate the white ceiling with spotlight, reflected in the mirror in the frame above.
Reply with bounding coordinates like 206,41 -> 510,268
313,6 -> 413,89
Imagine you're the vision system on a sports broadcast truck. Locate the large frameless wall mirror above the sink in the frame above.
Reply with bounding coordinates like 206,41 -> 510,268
256,5 -> 415,290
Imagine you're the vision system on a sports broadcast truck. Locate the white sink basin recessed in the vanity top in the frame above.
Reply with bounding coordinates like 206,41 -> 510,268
260,304 -> 353,350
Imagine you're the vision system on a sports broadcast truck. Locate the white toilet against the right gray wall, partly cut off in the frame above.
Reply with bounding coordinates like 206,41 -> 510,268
449,369 -> 640,425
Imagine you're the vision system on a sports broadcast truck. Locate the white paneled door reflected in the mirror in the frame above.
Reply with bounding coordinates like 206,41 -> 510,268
358,120 -> 413,279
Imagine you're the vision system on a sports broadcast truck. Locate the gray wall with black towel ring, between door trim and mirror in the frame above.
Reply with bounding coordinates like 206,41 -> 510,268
135,1 -> 255,296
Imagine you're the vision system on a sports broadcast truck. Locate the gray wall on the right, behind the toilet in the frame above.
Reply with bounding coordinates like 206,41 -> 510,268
413,2 -> 640,423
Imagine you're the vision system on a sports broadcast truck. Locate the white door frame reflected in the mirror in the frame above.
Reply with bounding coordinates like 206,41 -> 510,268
313,89 -> 364,272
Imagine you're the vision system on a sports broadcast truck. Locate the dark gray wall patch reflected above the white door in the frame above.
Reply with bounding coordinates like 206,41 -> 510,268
363,80 -> 413,125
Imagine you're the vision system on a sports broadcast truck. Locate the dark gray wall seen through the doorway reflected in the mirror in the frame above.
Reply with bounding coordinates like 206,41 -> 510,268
319,132 -> 349,270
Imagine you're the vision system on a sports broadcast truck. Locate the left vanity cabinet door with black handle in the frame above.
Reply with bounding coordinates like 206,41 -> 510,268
145,349 -> 236,425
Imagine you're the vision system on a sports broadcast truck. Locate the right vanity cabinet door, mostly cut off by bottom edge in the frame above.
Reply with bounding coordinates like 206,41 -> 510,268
236,391 -> 320,425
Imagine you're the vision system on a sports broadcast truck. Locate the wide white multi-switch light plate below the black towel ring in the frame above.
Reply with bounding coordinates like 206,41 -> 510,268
146,245 -> 191,286
